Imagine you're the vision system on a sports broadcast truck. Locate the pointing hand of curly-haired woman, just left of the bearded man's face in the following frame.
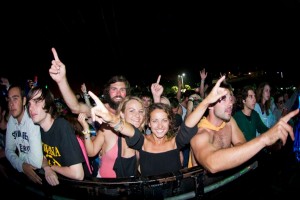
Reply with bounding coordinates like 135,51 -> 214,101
88,91 -> 114,124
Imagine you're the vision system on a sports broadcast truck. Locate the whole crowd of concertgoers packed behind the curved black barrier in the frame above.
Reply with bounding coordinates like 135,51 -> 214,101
0,48 -> 300,192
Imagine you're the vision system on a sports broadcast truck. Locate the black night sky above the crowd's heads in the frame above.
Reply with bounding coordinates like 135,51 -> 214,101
0,0 -> 300,94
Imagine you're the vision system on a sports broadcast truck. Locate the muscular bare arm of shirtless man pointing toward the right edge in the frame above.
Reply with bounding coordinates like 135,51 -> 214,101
191,109 -> 299,173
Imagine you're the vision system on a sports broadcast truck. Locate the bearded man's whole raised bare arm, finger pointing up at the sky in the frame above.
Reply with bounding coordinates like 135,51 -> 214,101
49,48 -> 91,116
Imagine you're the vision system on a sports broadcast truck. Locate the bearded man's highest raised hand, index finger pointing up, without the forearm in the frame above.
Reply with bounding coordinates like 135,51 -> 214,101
49,48 -> 66,83
